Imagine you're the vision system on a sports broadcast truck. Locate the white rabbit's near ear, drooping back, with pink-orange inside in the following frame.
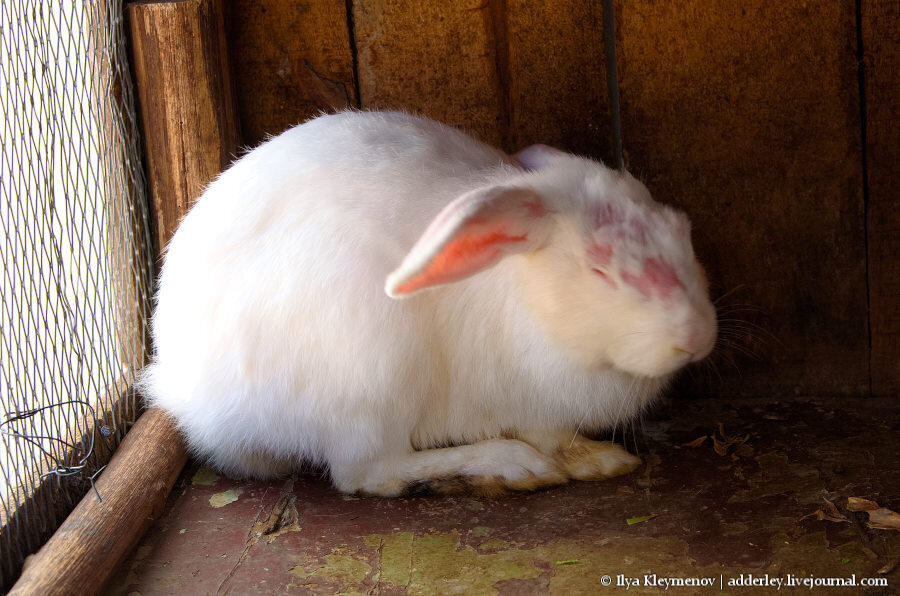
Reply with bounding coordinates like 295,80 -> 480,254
385,186 -> 552,298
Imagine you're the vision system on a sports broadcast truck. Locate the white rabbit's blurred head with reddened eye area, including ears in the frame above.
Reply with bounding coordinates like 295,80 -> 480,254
386,146 -> 717,377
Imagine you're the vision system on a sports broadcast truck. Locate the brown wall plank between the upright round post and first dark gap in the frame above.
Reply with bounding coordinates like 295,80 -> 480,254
226,0 -> 357,146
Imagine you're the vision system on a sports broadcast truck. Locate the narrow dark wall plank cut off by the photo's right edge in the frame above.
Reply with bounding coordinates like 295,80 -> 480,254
861,0 -> 900,396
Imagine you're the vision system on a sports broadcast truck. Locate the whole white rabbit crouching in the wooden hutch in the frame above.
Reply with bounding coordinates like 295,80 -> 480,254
141,112 -> 716,496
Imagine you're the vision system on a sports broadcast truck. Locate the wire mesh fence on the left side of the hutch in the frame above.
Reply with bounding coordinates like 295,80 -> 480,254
0,0 -> 153,590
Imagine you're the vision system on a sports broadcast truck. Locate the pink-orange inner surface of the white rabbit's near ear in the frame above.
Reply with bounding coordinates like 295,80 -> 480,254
395,227 -> 528,294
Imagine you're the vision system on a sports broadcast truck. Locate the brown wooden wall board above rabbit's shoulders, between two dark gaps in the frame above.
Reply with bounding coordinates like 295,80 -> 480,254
353,0 -> 611,159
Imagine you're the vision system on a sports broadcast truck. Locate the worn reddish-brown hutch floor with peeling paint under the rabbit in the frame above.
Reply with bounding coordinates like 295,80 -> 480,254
110,399 -> 900,595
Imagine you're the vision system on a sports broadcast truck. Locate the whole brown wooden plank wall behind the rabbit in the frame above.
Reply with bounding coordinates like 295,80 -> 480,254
226,0 -> 900,397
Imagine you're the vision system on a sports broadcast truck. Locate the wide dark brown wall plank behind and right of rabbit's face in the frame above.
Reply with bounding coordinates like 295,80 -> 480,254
616,0 -> 868,396
